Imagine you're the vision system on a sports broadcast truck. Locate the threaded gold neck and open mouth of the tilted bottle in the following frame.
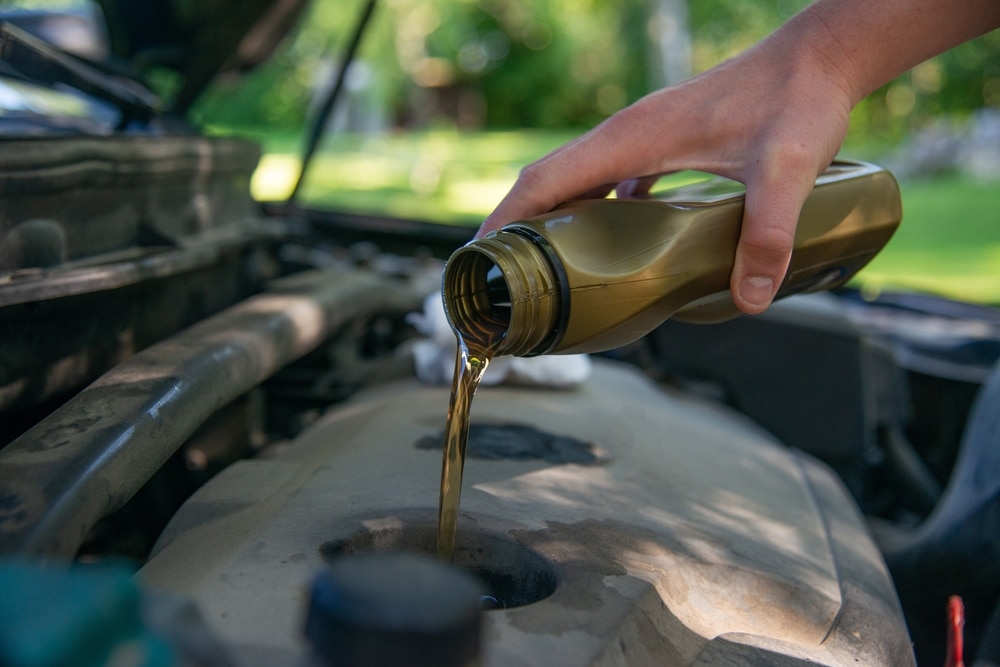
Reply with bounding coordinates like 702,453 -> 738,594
442,229 -> 568,357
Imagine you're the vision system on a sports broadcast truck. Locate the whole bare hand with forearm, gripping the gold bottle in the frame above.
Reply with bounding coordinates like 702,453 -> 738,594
478,0 -> 1000,313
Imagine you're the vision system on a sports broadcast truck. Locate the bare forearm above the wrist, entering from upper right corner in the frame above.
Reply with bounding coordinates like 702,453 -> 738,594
776,0 -> 1000,104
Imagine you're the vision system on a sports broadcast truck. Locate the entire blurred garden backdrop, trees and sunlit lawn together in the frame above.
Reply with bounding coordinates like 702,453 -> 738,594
189,0 -> 1000,305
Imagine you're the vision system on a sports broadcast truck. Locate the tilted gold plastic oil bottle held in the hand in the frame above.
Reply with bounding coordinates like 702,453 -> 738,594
442,162 -> 902,356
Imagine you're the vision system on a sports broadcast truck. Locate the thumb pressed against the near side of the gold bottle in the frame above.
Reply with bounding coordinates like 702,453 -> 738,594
730,172 -> 815,315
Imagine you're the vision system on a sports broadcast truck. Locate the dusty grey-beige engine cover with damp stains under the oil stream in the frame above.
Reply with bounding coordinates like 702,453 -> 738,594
139,361 -> 913,666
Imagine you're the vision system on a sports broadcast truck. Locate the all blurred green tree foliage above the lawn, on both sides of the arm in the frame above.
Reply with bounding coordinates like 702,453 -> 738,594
188,0 -> 1000,141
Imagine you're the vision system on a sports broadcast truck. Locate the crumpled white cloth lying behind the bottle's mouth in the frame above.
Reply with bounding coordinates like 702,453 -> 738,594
407,292 -> 591,389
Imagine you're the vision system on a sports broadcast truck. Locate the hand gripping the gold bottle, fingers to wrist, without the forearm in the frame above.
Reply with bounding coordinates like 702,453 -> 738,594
478,19 -> 856,313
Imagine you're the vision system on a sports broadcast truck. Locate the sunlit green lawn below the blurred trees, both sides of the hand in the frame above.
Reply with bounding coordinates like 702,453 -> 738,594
242,131 -> 1000,305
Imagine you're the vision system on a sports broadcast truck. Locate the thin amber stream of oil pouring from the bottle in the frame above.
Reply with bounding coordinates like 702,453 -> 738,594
437,335 -> 493,562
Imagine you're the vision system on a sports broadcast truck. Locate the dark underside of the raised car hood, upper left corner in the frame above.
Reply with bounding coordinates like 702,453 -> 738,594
0,0 -> 309,121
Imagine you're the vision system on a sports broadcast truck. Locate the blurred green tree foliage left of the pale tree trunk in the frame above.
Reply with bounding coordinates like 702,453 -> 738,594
190,0 -> 649,128
